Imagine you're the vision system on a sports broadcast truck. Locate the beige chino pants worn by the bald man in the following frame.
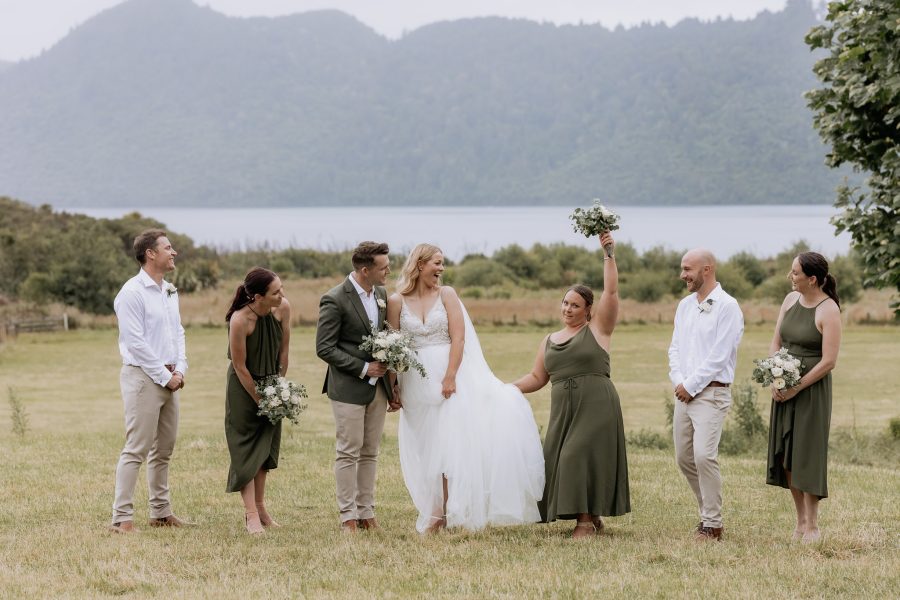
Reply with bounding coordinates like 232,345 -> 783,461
672,387 -> 731,527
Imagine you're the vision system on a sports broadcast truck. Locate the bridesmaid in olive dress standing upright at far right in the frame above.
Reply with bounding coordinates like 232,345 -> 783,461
766,252 -> 841,543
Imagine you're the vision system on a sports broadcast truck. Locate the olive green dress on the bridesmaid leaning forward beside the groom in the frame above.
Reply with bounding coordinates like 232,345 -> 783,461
225,314 -> 282,492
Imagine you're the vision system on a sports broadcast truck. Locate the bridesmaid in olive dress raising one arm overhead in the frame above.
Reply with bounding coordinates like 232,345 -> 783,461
514,232 -> 631,538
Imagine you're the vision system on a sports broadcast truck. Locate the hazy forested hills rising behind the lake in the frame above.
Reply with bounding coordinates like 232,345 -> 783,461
0,0 -> 838,207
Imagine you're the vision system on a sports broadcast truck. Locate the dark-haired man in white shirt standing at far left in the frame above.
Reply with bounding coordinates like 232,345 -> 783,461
110,229 -> 188,533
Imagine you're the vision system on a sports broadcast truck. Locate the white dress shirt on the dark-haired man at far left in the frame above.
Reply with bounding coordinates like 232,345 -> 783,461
113,269 -> 187,386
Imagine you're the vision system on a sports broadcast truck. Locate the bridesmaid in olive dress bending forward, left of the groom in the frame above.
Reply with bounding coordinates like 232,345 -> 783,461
225,267 -> 291,534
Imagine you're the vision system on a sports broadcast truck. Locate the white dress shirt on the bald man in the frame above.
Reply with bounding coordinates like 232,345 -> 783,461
669,283 -> 744,396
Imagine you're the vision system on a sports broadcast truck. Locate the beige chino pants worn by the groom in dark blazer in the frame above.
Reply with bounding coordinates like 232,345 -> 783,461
331,381 -> 387,523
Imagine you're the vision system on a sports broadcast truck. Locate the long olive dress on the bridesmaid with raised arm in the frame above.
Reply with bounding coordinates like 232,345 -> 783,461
538,326 -> 631,522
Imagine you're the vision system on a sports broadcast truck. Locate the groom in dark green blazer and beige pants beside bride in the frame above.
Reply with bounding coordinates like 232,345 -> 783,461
316,242 -> 399,533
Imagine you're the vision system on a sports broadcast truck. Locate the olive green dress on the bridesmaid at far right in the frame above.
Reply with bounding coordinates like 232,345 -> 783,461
766,298 -> 831,498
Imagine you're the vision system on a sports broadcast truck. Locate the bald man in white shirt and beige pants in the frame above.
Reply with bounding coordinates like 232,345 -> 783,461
669,249 -> 744,540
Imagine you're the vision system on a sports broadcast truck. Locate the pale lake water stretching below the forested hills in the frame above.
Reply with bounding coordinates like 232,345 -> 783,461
79,205 -> 850,260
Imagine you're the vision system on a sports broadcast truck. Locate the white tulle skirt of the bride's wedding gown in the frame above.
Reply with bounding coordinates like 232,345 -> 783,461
398,344 -> 544,531
